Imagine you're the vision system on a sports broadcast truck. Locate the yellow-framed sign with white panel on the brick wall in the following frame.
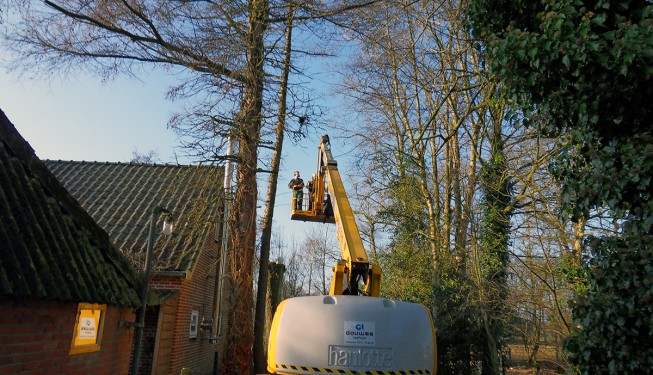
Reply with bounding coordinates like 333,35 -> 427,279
70,303 -> 107,354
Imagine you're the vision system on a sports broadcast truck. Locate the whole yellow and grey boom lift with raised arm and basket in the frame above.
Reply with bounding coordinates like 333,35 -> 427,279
268,136 -> 437,375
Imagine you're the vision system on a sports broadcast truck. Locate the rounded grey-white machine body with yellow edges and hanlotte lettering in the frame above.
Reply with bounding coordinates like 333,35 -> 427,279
268,295 -> 436,374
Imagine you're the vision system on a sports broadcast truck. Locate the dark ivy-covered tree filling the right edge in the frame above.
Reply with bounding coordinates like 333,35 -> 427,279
467,0 -> 653,374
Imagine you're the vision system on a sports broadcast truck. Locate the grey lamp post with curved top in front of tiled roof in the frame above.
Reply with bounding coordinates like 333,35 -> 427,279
131,206 -> 173,375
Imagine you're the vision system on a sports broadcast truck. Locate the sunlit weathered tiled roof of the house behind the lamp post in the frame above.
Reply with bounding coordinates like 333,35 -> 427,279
44,160 -> 223,272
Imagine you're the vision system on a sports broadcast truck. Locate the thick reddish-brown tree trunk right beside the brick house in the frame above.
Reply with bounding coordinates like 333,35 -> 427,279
222,0 -> 269,375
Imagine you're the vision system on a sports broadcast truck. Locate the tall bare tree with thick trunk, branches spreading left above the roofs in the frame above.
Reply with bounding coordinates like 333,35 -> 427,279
6,0 -> 380,374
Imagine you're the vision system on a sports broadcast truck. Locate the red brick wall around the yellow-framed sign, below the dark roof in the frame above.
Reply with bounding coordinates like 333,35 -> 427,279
0,299 -> 135,375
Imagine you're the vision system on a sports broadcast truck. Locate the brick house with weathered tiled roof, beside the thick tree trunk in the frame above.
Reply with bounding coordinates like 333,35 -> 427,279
44,160 -> 228,375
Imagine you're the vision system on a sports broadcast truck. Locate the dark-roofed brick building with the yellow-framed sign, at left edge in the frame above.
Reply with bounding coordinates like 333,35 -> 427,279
0,111 -> 140,375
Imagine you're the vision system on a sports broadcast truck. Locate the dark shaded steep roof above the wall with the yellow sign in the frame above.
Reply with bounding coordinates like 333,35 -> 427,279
0,110 -> 140,306
